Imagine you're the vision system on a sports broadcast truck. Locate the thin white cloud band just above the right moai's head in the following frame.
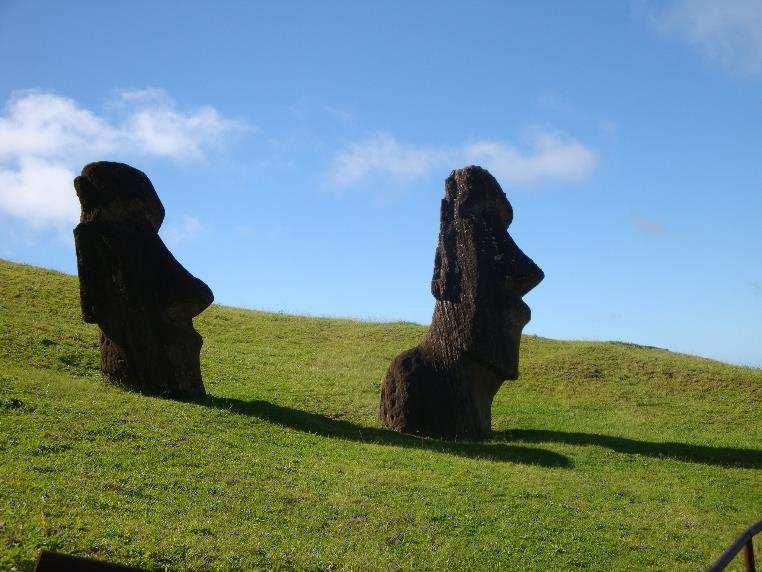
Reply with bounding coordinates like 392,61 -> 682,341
330,129 -> 598,187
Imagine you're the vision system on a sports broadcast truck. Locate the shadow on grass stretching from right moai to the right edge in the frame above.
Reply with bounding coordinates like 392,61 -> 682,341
494,429 -> 762,469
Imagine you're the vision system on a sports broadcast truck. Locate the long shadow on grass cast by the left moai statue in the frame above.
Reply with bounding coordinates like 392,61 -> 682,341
193,395 -> 571,467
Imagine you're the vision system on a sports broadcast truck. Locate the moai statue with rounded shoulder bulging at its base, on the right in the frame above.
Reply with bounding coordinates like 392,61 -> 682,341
379,166 -> 544,440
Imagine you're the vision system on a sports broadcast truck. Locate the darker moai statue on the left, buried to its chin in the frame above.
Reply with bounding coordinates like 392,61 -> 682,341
74,161 -> 214,397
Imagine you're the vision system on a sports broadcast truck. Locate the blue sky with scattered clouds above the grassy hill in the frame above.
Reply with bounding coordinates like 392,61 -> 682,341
0,0 -> 762,366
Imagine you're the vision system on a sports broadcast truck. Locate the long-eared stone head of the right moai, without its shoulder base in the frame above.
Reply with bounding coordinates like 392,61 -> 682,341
432,167 -> 544,379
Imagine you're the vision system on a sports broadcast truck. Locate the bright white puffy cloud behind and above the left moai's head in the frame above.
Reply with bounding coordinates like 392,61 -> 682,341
0,88 -> 245,227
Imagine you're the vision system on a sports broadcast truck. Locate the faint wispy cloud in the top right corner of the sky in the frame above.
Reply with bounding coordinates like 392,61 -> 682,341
651,0 -> 762,74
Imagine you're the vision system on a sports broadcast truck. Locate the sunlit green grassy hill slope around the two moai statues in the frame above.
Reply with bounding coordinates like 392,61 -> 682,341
0,261 -> 762,570
